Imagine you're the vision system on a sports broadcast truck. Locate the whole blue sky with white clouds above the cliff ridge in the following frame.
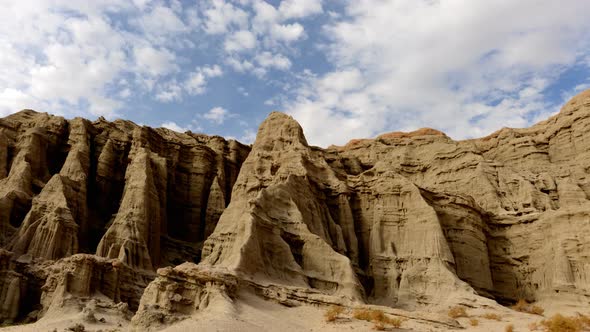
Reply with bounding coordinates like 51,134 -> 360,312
0,0 -> 590,146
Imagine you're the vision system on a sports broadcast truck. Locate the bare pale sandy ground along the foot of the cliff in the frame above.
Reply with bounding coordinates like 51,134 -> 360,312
0,293 -> 590,332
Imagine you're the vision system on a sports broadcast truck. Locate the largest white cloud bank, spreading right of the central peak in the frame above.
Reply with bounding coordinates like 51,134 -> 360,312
284,0 -> 590,145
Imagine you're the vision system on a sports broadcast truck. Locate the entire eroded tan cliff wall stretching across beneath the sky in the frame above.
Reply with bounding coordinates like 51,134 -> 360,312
0,91 -> 590,330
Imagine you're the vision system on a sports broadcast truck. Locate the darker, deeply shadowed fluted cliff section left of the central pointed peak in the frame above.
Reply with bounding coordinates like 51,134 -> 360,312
0,111 -> 250,321
